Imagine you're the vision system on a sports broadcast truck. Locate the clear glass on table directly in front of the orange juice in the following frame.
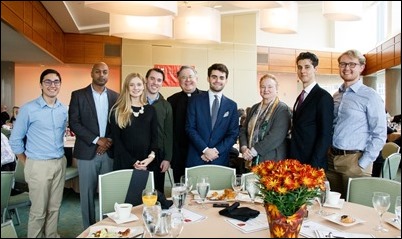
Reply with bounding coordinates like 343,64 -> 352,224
142,202 -> 162,237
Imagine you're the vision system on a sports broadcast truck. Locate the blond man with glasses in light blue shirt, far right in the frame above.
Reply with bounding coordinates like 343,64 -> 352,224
327,50 -> 387,198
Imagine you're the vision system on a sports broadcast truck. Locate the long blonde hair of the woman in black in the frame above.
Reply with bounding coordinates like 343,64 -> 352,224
109,73 -> 147,129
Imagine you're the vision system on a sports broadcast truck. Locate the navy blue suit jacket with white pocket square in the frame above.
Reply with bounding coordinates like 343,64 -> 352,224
186,92 -> 239,167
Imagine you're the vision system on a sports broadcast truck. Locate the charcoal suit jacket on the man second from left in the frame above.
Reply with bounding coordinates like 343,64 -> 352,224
68,85 -> 119,160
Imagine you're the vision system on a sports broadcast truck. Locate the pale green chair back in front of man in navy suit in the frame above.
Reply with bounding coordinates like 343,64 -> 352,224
185,164 -> 236,190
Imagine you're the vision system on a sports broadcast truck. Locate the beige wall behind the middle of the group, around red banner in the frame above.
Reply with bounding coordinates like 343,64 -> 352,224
122,14 -> 259,107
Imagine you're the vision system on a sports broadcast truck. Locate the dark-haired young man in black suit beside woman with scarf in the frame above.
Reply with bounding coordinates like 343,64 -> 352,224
289,52 -> 334,170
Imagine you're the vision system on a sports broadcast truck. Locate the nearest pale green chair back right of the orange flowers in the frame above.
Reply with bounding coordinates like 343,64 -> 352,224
346,177 -> 401,212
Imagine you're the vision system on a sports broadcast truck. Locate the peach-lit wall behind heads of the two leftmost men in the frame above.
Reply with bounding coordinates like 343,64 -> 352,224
14,65 -> 121,108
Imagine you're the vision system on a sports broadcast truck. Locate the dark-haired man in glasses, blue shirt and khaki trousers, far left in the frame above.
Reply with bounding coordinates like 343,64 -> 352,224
10,69 -> 67,238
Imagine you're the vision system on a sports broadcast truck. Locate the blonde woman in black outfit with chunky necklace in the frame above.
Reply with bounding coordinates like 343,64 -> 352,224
109,73 -> 158,171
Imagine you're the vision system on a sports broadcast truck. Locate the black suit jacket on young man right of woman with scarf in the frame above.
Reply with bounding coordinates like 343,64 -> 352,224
289,84 -> 334,169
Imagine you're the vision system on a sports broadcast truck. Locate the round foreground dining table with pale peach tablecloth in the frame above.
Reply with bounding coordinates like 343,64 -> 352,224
75,193 -> 401,238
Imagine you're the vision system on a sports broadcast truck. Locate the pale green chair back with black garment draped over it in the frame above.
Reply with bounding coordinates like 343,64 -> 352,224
99,169 -> 155,220
